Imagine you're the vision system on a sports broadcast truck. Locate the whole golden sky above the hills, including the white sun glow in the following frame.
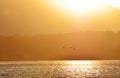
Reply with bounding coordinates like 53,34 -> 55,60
0,0 -> 120,35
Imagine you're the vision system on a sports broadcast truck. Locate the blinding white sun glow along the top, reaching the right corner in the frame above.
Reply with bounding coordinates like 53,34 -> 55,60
47,0 -> 120,17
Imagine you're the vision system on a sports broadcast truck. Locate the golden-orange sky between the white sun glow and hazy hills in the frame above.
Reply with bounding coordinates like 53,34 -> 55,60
0,0 -> 120,34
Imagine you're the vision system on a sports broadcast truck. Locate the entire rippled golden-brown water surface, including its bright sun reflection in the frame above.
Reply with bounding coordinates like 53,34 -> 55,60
0,60 -> 120,78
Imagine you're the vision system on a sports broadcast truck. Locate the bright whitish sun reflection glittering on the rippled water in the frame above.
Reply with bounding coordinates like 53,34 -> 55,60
62,61 -> 101,78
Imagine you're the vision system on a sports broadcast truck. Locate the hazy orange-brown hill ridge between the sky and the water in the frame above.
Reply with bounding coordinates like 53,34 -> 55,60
0,31 -> 120,60
